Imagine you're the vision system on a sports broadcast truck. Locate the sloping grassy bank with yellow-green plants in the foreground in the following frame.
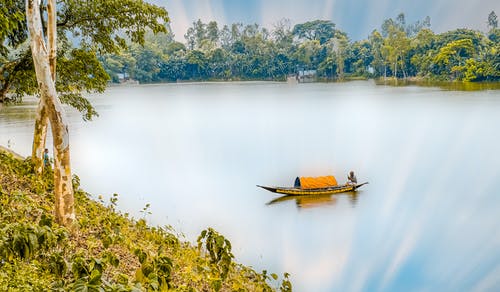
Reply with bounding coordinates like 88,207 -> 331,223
0,149 -> 291,291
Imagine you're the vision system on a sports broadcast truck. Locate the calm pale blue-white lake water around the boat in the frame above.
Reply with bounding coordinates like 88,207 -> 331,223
0,81 -> 500,291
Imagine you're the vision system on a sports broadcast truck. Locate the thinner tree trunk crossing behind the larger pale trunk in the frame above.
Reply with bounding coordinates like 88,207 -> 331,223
31,0 -> 57,174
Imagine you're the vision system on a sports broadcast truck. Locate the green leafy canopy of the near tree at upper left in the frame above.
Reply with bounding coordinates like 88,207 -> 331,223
0,0 -> 169,120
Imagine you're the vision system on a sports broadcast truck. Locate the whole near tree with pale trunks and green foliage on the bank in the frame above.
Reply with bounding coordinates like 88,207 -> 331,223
8,0 -> 168,224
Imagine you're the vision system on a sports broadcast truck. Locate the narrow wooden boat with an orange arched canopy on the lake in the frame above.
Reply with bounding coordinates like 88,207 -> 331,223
257,176 -> 368,196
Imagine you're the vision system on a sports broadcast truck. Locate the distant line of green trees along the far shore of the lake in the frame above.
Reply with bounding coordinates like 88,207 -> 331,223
99,11 -> 500,83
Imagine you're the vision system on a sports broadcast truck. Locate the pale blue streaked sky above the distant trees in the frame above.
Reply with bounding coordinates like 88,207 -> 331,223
150,0 -> 500,42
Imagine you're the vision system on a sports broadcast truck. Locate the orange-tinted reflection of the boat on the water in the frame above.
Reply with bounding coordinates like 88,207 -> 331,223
266,192 -> 358,209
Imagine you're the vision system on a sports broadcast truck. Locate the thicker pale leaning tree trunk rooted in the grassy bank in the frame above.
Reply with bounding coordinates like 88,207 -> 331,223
26,0 -> 75,225
